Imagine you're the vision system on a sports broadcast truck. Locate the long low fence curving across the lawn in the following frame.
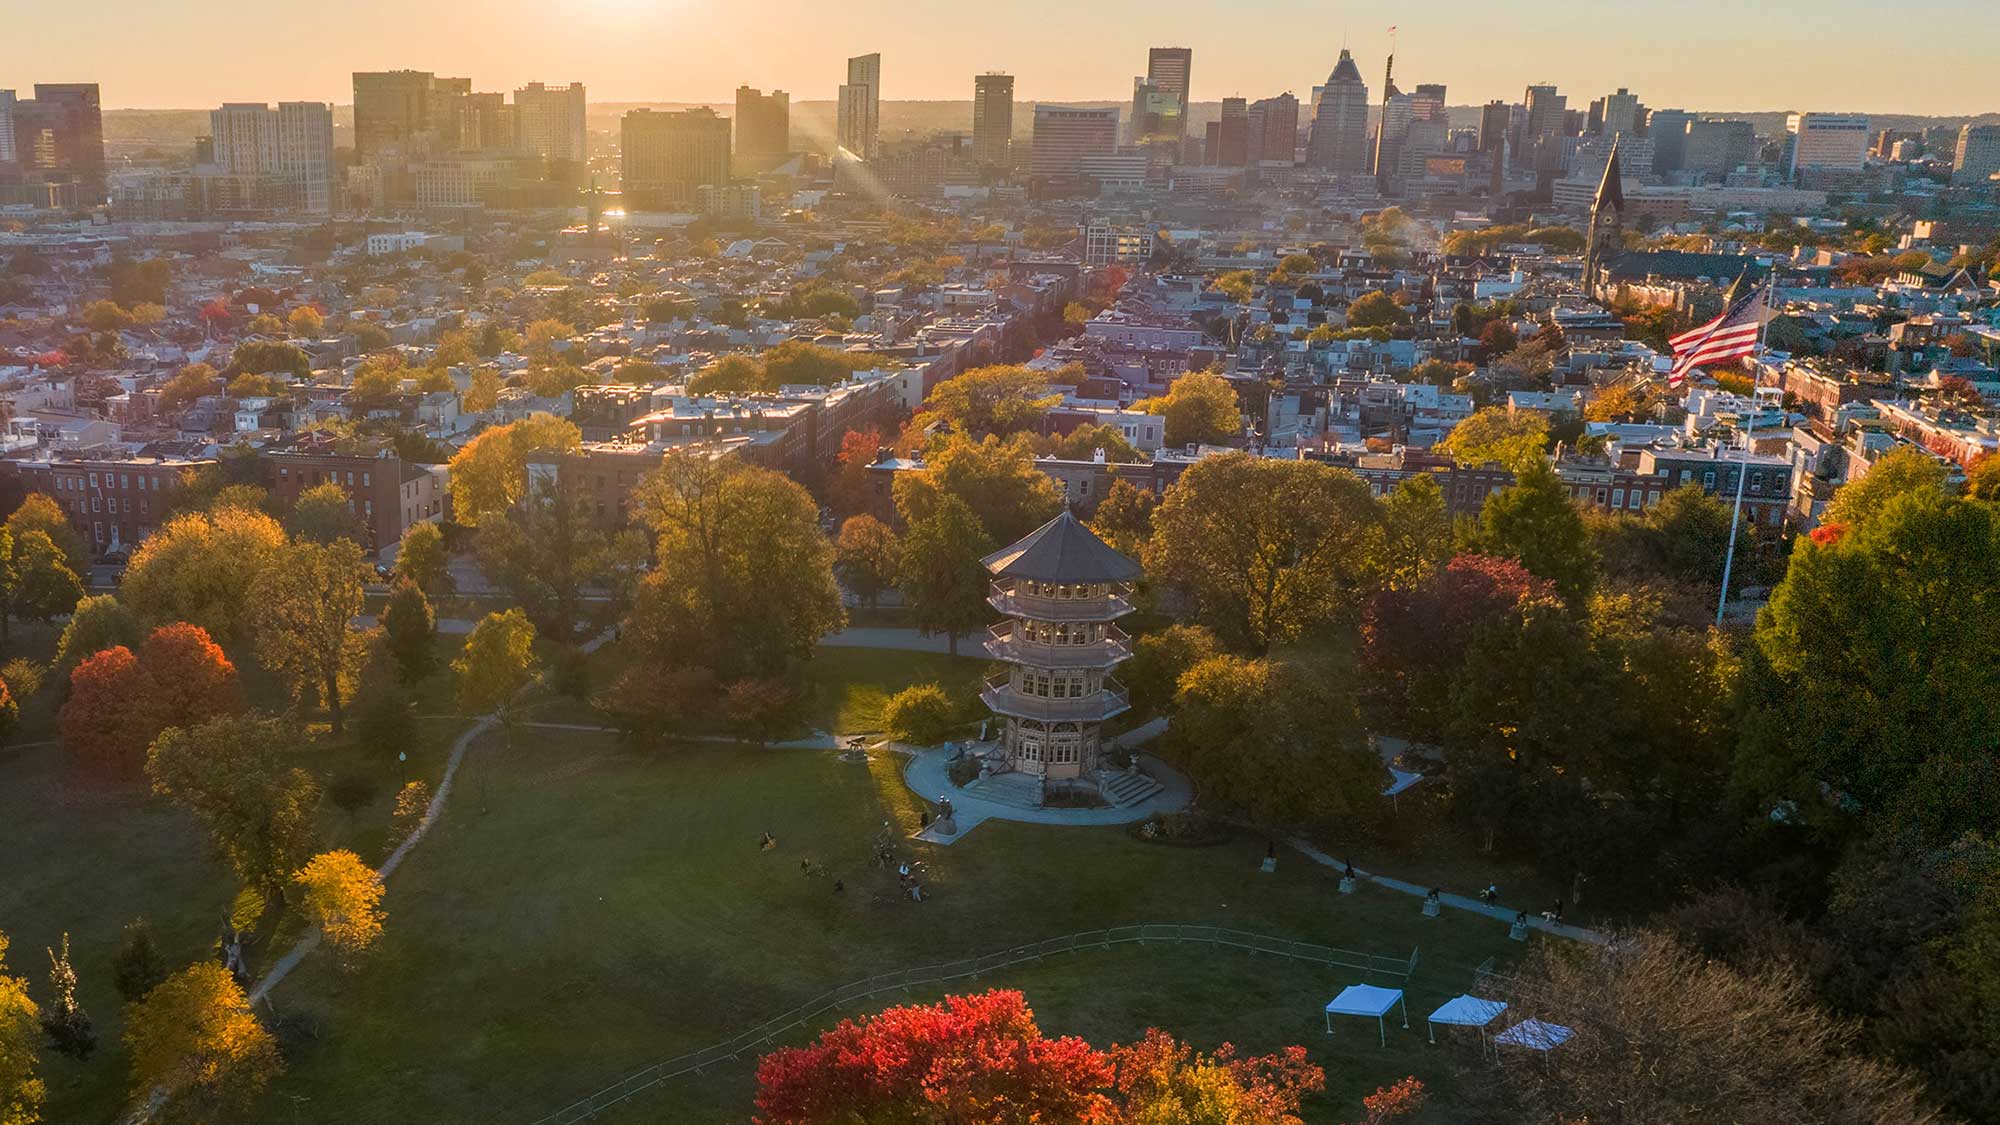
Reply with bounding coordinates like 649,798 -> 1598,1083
534,923 -> 1418,1125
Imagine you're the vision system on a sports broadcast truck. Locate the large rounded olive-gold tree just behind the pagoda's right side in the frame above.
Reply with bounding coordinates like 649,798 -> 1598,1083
1146,452 -> 1380,651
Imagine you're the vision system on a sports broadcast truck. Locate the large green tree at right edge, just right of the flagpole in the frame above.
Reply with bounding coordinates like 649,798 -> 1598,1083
1738,486 -> 2000,843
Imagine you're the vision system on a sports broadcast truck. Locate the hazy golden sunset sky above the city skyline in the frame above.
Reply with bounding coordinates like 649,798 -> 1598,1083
0,0 -> 2000,114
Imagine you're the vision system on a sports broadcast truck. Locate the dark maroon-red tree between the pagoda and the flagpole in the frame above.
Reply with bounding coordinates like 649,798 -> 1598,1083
1362,554 -> 1554,739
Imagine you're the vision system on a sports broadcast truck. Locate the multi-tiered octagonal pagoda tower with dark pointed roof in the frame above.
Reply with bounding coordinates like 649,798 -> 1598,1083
980,510 -> 1142,781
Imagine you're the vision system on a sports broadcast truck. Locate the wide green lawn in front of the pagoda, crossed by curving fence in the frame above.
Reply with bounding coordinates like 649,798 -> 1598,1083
266,733 -> 1518,1123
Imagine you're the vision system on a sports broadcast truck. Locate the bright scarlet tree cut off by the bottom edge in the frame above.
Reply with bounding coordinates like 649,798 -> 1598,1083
756,991 -> 1112,1125
